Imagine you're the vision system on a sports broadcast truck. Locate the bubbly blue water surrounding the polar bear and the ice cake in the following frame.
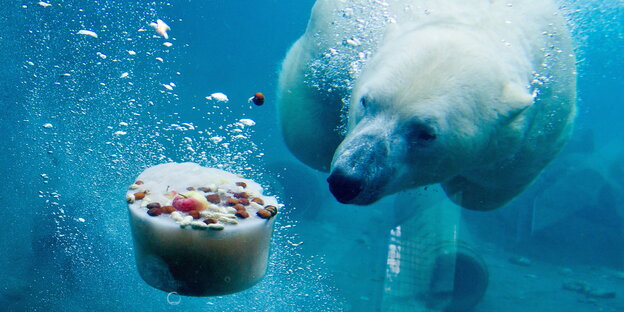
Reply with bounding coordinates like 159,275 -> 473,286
0,0 -> 624,311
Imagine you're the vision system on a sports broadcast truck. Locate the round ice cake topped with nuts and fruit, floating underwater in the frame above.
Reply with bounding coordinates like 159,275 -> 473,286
126,163 -> 280,296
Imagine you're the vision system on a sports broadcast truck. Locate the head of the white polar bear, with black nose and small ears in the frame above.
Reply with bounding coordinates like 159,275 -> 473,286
328,26 -> 533,205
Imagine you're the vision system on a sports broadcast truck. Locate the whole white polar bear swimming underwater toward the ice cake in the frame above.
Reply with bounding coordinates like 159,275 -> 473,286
278,0 -> 576,210
